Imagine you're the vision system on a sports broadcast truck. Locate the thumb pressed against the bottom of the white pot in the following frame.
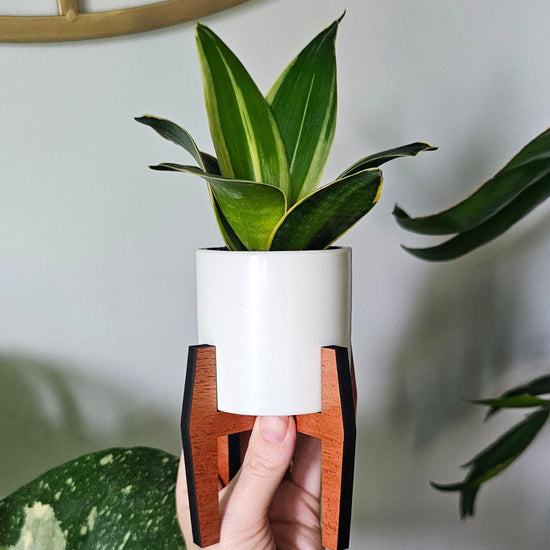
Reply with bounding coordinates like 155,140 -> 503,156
224,416 -> 296,528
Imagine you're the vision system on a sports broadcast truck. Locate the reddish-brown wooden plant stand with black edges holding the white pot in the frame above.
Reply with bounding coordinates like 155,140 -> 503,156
181,345 -> 356,550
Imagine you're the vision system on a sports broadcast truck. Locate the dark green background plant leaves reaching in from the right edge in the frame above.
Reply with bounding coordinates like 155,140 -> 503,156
394,129 -> 550,518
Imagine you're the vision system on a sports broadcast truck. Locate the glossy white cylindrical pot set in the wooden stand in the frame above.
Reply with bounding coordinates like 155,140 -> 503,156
197,247 -> 351,415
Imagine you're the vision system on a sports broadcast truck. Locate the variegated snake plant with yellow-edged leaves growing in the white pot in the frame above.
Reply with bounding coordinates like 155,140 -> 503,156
136,14 -> 435,250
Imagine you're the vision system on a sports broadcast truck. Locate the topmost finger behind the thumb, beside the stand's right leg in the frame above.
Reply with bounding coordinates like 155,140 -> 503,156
290,433 -> 321,499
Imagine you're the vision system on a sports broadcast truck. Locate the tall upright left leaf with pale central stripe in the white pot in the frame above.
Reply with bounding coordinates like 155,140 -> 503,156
196,23 -> 290,199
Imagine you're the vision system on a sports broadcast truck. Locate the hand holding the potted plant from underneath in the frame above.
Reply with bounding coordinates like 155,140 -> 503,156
176,417 -> 323,550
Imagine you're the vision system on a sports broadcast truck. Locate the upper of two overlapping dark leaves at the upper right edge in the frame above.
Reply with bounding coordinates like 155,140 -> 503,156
394,128 -> 550,235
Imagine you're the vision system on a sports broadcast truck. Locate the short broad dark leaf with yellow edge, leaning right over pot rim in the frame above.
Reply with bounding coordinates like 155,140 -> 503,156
269,168 -> 382,250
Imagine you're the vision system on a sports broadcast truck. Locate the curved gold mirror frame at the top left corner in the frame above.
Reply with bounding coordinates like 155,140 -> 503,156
0,0 -> 252,42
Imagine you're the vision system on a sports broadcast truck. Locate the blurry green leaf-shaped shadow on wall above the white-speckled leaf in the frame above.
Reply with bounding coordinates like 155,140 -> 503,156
0,355 -> 180,499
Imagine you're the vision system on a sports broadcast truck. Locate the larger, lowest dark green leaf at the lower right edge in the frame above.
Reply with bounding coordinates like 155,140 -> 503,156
431,407 -> 550,518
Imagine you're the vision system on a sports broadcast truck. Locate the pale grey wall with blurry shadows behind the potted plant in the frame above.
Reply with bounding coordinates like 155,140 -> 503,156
0,0 -> 550,550
